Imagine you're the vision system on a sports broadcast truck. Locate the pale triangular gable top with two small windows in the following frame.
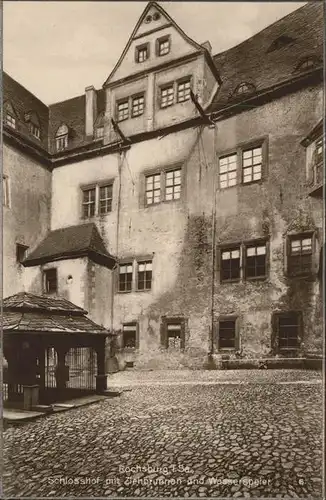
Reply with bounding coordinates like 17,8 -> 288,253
105,2 -> 203,85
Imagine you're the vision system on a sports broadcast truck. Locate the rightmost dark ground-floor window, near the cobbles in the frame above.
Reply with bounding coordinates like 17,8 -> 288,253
274,312 -> 301,351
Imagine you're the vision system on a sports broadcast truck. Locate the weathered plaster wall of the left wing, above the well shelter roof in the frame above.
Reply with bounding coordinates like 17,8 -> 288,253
3,143 -> 51,297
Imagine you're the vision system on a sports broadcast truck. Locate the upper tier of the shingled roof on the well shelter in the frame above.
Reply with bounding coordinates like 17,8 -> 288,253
3,292 -> 87,315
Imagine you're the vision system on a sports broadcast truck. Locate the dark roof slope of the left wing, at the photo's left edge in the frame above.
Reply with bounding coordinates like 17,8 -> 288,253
2,72 -> 49,151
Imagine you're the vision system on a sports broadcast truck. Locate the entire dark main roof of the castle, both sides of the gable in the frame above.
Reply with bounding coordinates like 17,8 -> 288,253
3,1 -> 324,154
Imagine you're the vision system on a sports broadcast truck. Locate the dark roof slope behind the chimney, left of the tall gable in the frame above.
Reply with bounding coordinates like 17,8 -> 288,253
49,89 -> 105,153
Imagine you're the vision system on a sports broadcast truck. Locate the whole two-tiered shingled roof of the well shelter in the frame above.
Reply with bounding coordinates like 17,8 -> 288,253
2,292 -> 110,335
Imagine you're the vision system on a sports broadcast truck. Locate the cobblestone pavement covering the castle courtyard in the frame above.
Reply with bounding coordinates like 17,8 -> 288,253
4,371 -> 322,499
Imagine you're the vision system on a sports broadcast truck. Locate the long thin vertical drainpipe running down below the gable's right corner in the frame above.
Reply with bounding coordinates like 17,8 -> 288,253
209,122 -> 217,358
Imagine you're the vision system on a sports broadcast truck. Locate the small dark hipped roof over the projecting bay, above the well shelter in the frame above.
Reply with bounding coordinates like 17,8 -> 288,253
23,222 -> 115,269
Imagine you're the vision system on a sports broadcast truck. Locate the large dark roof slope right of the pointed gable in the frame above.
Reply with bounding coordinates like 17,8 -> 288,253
212,2 -> 324,110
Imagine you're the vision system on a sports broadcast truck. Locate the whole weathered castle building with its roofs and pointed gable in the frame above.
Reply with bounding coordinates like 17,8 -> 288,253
3,2 -> 324,368
